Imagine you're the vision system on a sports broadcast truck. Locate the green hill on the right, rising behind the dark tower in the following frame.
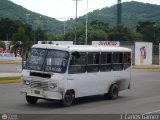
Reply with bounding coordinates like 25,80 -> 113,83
78,1 -> 160,27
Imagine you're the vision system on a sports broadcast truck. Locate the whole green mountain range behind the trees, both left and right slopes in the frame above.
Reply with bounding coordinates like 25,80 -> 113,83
0,0 -> 160,34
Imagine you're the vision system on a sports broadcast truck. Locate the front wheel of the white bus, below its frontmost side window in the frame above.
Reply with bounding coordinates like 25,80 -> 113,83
62,90 -> 75,107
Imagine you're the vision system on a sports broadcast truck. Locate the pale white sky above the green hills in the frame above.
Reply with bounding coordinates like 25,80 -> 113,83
10,0 -> 160,21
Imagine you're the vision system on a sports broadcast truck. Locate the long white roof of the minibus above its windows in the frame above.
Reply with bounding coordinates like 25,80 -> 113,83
32,44 -> 132,52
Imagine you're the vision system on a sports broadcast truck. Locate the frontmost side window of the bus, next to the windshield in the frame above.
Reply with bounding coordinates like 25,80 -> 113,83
68,52 -> 86,74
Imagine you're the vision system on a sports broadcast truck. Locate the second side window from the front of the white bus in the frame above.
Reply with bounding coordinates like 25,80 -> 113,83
87,52 -> 99,72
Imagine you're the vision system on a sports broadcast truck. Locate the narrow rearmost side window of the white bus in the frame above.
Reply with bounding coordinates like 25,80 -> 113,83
123,52 -> 131,70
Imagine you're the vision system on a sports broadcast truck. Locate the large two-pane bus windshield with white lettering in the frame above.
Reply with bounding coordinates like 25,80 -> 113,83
25,48 -> 69,73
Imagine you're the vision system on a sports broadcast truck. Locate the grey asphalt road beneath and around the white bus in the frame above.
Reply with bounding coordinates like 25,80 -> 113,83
0,70 -> 160,118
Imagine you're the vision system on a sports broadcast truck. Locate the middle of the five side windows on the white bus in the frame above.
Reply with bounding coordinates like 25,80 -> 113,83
100,52 -> 112,72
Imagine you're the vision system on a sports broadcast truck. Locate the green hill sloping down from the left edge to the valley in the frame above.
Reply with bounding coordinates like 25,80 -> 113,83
0,0 -> 63,34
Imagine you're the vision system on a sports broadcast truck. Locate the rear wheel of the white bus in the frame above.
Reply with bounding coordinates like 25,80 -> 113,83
108,84 -> 119,100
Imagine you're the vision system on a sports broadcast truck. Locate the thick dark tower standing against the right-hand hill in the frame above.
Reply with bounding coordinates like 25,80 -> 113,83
117,0 -> 122,25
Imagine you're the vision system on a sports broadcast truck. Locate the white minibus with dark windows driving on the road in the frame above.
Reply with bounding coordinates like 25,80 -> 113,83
21,44 -> 132,106
